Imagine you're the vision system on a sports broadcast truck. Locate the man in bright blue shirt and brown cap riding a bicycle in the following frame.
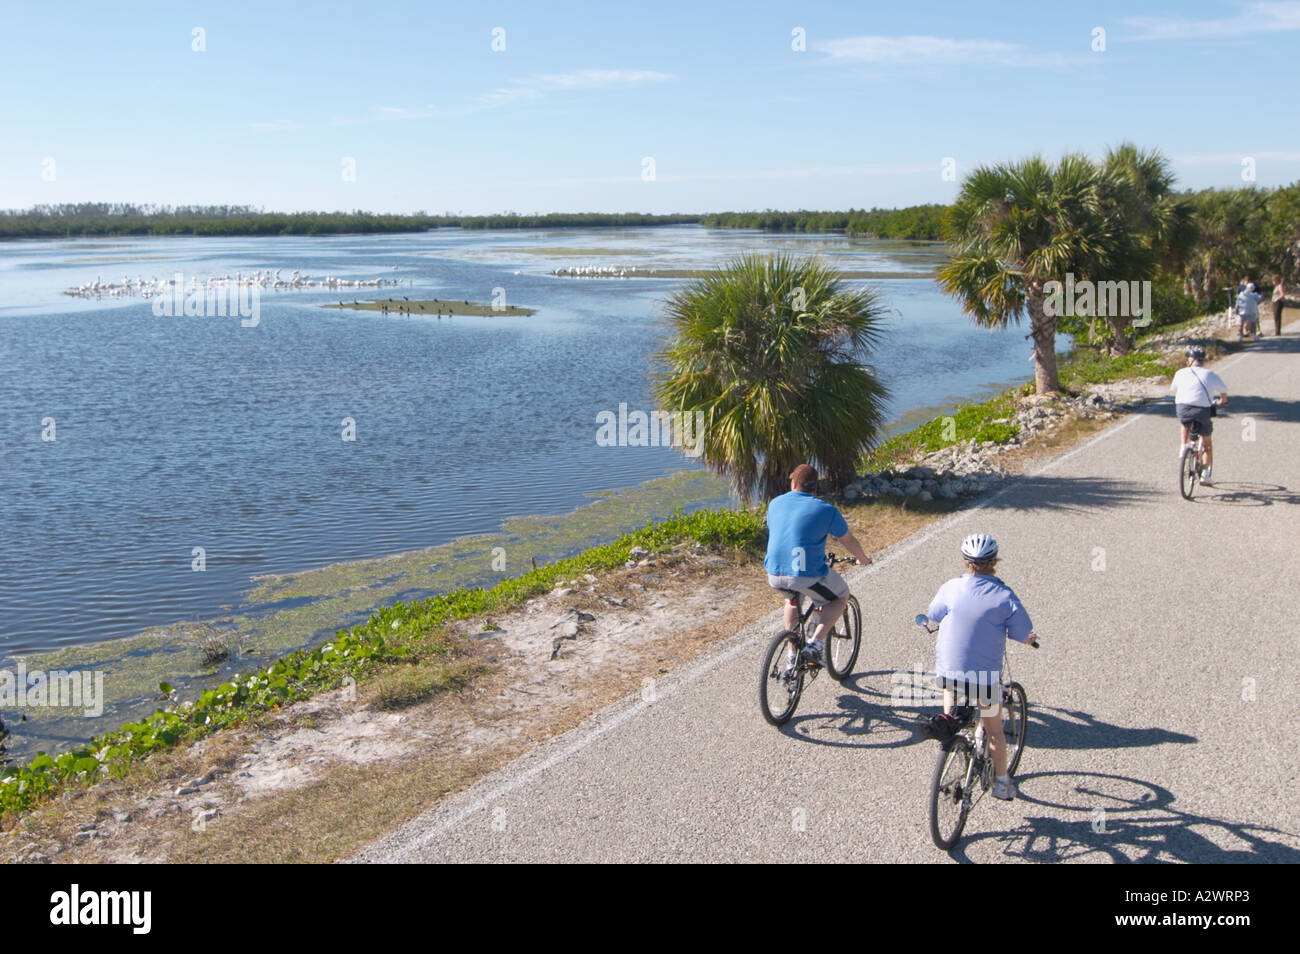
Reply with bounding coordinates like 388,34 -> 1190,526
763,464 -> 871,665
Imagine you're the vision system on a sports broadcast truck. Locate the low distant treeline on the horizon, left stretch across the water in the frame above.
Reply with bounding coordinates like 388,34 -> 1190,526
0,203 -> 699,238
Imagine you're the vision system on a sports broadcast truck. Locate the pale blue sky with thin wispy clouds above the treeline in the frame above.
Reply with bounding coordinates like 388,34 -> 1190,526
0,0 -> 1300,213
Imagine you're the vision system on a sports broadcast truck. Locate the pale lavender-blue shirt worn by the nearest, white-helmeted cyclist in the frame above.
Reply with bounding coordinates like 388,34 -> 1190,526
927,573 -> 1034,685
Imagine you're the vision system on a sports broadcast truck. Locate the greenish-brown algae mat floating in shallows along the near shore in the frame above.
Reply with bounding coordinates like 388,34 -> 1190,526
5,471 -> 735,758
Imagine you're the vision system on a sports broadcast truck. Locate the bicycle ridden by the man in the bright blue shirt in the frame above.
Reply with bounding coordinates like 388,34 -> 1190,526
758,554 -> 862,725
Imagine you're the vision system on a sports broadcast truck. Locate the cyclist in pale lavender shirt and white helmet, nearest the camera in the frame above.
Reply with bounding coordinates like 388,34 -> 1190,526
927,533 -> 1037,801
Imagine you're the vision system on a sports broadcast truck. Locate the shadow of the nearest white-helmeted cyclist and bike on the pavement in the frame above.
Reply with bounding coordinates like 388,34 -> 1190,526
949,772 -> 1300,864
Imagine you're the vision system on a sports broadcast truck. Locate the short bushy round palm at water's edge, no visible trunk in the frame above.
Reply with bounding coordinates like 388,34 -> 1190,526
655,255 -> 888,506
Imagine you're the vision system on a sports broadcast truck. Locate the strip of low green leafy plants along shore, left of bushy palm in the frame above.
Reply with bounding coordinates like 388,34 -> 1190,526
0,508 -> 764,818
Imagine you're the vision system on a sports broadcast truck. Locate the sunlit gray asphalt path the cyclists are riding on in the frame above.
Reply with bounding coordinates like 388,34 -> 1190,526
359,337 -> 1300,863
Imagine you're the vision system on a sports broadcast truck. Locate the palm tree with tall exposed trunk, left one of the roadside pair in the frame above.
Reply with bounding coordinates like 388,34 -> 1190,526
939,155 -> 1112,394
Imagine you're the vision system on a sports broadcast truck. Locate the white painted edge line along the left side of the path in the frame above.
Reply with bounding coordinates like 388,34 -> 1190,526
371,351 -> 1249,854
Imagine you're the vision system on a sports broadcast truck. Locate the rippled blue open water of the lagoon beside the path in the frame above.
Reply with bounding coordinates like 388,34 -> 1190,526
0,226 -> 1055,655
